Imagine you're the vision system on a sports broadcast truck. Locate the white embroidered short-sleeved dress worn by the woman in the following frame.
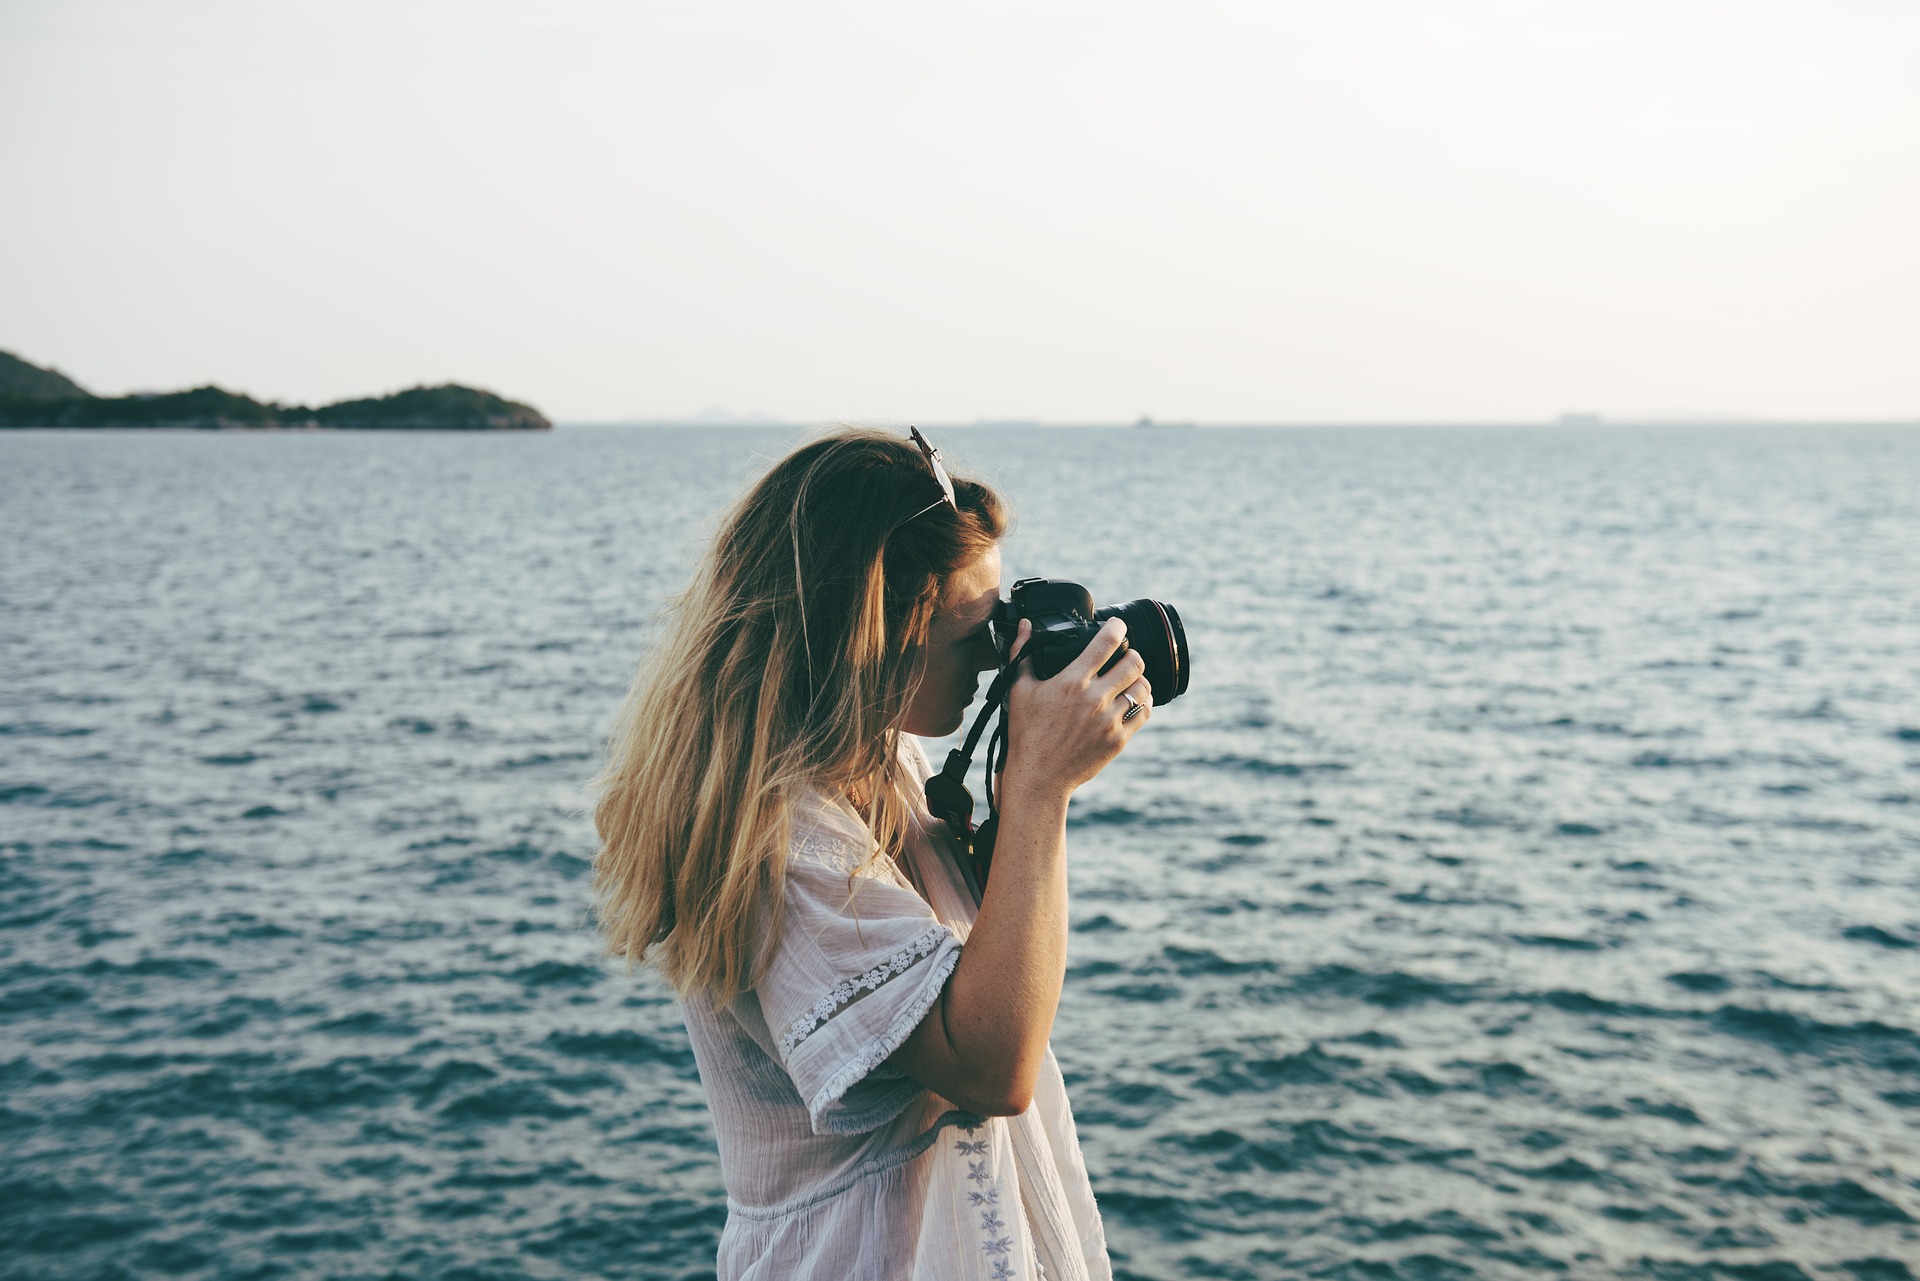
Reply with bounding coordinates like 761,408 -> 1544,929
682,737 -> 1114,1281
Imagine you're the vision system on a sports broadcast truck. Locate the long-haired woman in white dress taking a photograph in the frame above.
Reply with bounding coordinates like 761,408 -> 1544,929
595,428 -> 1152,1281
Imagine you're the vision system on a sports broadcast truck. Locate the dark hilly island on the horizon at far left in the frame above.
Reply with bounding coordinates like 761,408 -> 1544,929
0,351 -> 553,432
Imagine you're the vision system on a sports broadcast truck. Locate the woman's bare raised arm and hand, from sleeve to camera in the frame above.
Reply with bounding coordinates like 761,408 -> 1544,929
887,618 -> 1152,1116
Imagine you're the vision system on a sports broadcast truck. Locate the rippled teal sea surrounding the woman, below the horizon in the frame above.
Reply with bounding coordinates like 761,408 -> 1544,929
0,424 -> 1920,1281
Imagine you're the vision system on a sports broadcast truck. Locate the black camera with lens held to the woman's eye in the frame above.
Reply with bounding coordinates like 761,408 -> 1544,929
993,578 -> 1192,705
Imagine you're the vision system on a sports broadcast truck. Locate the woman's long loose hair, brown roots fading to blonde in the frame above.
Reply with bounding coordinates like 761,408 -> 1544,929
593,428 -> 1006,1004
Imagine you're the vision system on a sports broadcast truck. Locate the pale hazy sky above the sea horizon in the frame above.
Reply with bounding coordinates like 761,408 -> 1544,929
0,0 -> 1920,423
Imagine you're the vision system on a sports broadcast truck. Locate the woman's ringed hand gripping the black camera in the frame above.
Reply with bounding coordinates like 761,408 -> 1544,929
1000,618 -> 1154,795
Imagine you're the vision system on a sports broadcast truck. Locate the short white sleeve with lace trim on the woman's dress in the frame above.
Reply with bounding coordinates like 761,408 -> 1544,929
758,810 -> 960,1135
